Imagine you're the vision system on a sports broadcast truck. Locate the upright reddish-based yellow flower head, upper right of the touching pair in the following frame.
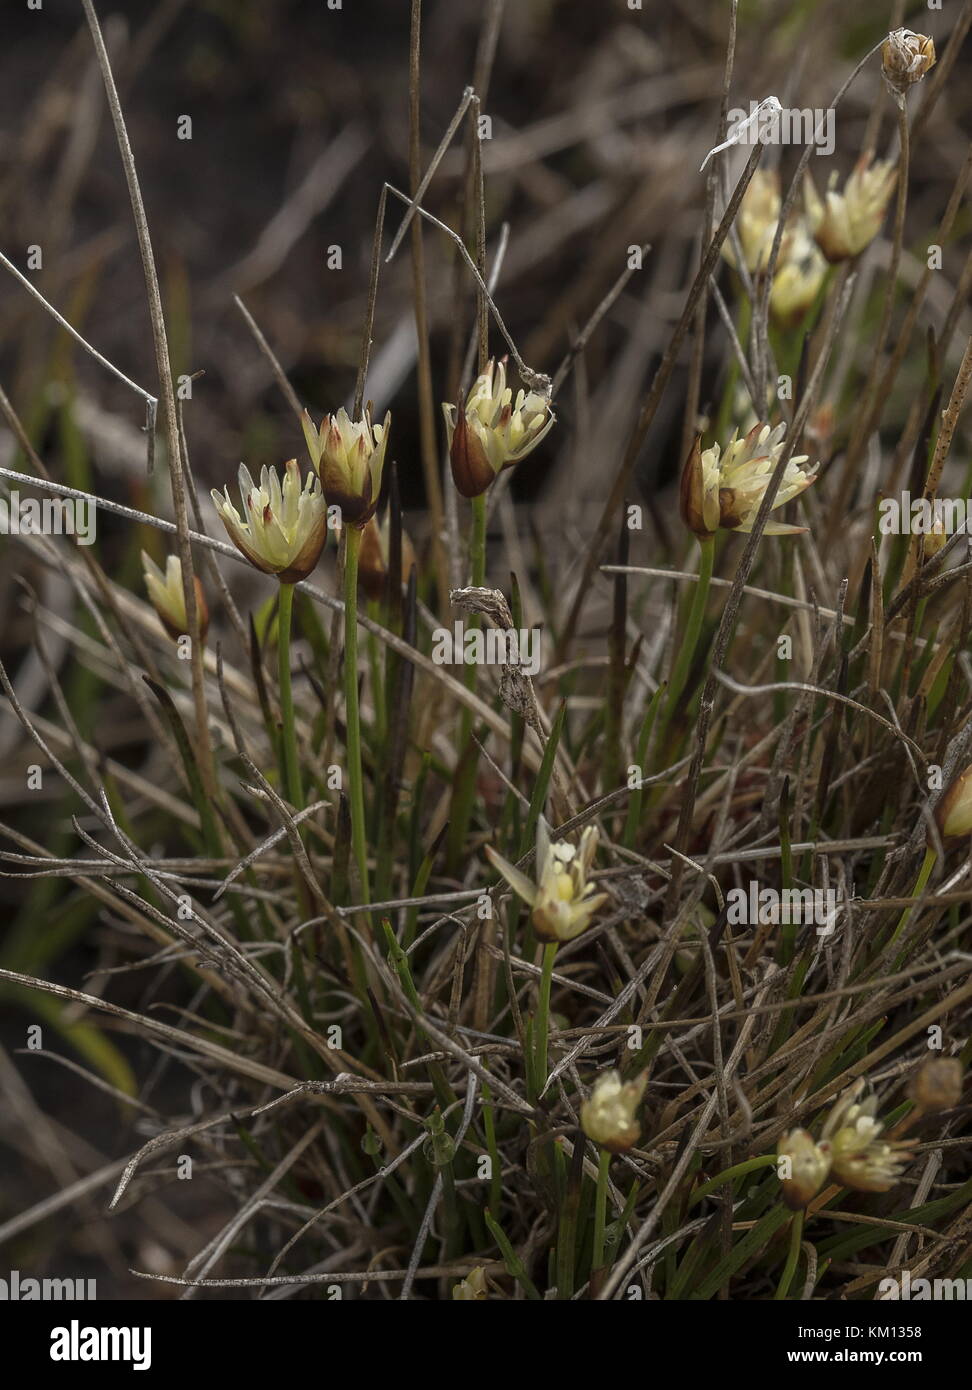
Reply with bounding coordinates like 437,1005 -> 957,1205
300,406 -> 392,531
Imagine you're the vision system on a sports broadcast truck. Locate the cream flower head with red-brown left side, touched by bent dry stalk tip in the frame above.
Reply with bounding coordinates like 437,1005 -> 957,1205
442,357 -> 555,498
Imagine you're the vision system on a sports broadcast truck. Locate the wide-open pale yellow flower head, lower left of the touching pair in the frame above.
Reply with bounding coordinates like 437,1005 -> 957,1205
213,459 -> 327,584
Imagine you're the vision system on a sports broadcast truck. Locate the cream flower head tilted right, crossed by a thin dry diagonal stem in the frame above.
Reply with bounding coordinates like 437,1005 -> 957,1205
680,423 -> 816,537
